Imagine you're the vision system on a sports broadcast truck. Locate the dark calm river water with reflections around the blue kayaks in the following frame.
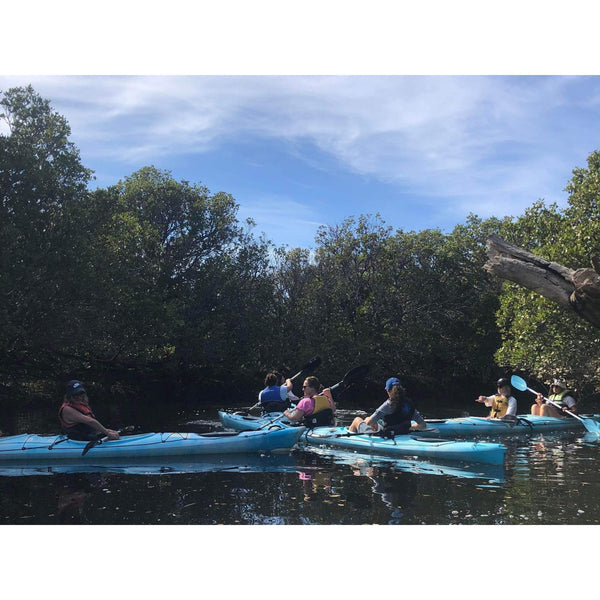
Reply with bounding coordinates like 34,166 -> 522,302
0,398 -> 600,525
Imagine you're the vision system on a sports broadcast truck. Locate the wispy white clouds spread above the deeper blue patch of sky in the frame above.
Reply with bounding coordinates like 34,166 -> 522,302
0,76 -> 600,234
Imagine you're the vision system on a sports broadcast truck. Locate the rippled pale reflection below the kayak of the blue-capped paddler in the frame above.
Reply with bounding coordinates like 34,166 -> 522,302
302,447 -> 506,483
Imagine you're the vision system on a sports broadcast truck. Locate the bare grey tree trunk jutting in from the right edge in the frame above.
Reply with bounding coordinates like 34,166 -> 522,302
484,235 -> 600,329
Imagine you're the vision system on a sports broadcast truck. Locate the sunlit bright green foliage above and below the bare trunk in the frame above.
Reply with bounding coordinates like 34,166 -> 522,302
496,152 -> 600,393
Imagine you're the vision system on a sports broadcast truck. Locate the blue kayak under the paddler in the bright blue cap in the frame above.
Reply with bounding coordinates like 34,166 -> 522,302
300,427 -> 506,465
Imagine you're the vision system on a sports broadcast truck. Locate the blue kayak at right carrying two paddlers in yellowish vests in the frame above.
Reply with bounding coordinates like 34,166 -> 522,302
419,415 -> 583,437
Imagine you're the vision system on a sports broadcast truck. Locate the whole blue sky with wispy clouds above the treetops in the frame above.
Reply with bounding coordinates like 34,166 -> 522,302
0,75 -> 600,247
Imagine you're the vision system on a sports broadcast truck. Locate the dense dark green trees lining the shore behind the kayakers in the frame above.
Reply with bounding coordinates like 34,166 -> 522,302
0,87 -> 600,409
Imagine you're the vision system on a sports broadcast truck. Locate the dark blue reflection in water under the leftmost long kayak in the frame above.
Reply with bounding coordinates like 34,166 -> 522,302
0,453 -> 299,477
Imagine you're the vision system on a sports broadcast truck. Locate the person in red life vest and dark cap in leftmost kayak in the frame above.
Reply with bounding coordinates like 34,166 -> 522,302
58,380 -> 119,441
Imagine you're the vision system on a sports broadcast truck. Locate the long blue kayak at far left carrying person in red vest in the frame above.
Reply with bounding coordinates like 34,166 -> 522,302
0,427 -> 304,463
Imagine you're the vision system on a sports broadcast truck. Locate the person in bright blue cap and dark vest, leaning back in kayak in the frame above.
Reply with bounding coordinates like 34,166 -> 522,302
348,377 -> 427,437
